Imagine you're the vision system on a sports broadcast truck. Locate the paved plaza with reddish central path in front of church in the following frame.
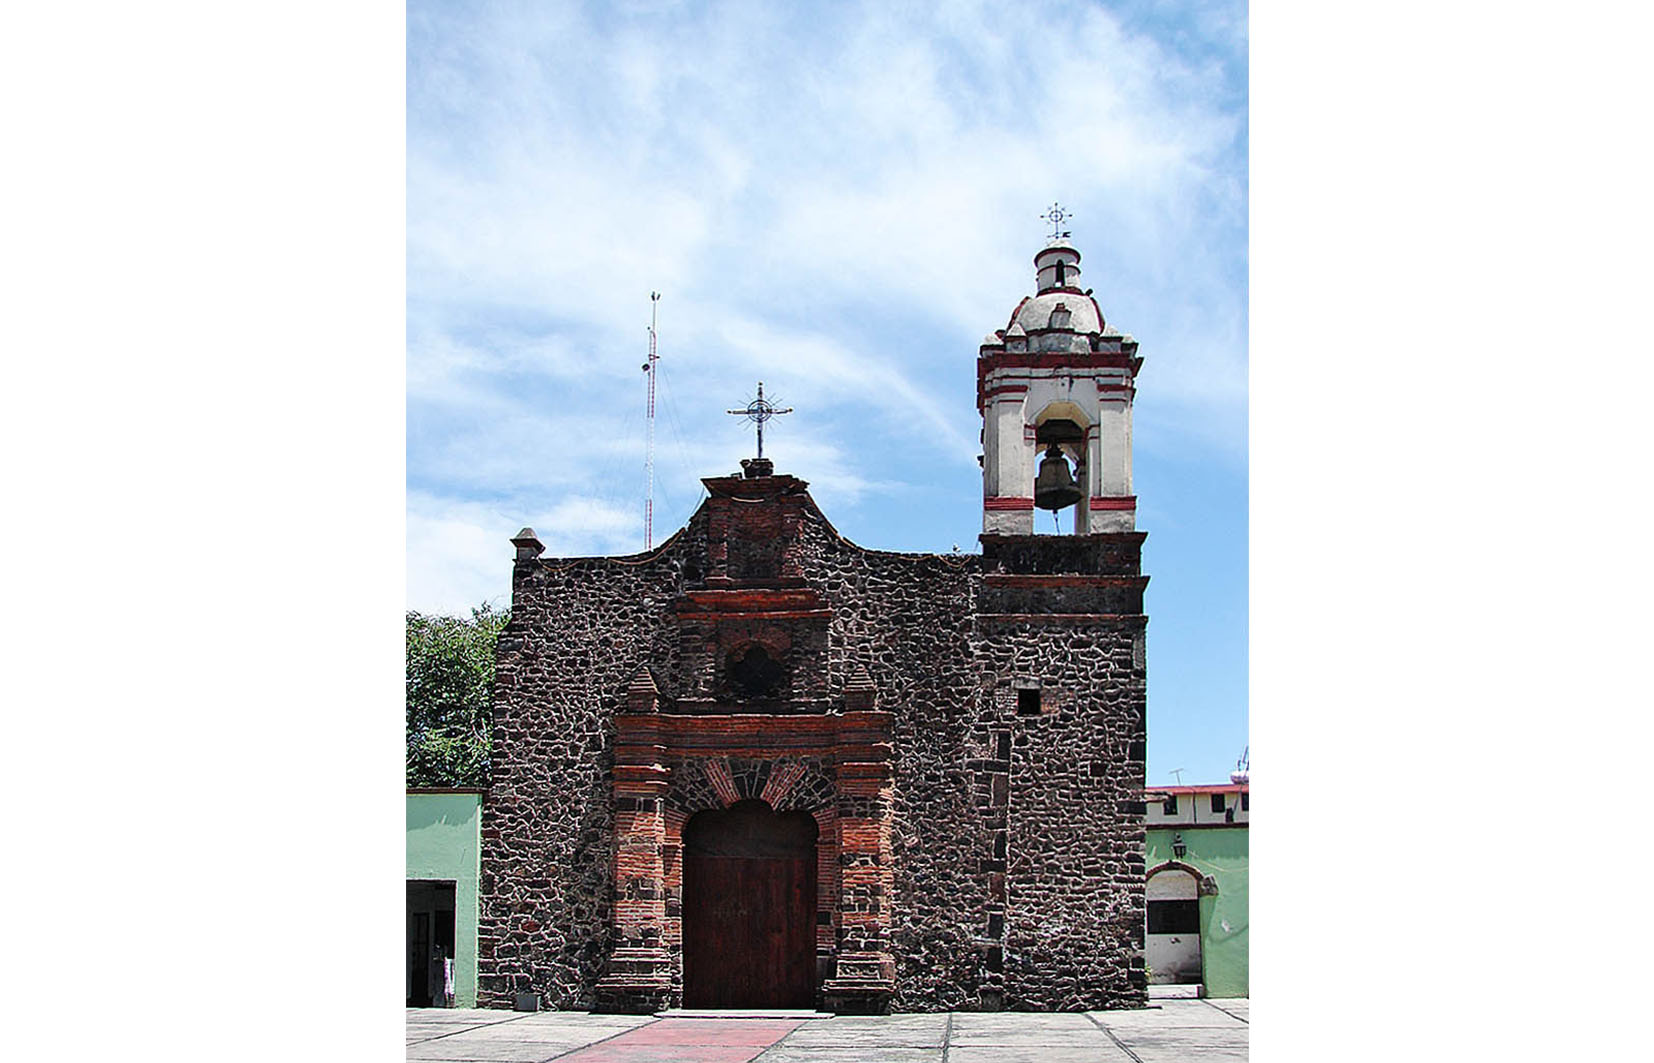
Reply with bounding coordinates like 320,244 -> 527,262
407,1000 -> 1249,1063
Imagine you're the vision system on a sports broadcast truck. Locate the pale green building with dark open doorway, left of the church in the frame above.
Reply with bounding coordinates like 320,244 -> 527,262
405,789 -> 483,1008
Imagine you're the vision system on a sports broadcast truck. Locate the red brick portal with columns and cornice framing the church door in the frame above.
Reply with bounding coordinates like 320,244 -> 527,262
597,673 -> 895,1013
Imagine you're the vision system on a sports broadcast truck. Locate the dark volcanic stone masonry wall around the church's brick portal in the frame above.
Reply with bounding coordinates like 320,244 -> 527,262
478,489 -> 1146,1012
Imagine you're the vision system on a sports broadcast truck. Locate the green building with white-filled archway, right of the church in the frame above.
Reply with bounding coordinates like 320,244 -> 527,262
1143,782 -> 1252,997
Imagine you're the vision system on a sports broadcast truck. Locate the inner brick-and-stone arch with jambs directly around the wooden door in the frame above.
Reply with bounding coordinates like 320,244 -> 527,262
662,757 -> 839,1000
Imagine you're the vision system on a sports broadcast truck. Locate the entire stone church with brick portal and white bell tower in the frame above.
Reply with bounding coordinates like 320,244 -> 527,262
478,238 -> 1148,1012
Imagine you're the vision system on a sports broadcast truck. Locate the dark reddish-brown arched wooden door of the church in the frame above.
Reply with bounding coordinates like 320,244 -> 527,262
683,800 -> 817,1008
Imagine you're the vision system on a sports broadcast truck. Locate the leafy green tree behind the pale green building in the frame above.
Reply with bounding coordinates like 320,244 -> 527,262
407,602 -> 509,787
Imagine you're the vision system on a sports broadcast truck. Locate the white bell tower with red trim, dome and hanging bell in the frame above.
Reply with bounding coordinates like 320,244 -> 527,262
976,231 -> 1143,536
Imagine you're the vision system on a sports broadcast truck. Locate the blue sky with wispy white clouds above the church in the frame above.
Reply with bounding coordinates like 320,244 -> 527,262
407,2 -> 1247,784
